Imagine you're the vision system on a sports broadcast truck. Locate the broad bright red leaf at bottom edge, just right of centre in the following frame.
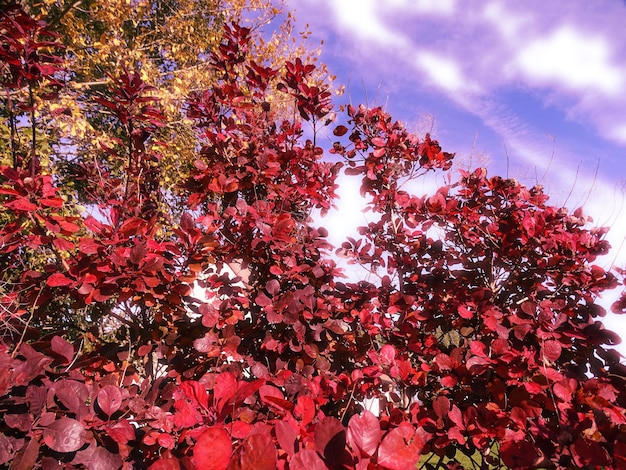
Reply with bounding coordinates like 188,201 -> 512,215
378,423 -> 424,470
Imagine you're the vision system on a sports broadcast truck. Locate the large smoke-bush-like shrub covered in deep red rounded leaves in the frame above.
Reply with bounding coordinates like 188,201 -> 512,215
0,7 -> 626,469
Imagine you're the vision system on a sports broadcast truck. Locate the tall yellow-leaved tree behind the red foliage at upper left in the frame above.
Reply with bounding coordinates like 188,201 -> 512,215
13,0 -> 329,210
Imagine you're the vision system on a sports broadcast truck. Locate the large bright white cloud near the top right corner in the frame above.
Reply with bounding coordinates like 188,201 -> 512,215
514,25 -> 623,95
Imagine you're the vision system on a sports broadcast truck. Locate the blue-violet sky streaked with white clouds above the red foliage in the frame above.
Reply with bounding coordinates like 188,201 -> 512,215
287,0 -> 626,352
